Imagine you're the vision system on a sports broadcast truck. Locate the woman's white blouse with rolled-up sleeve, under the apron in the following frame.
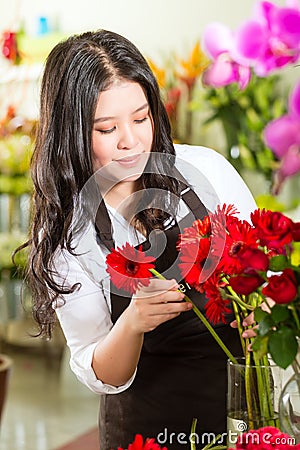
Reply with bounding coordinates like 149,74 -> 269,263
53,144 -> 256,394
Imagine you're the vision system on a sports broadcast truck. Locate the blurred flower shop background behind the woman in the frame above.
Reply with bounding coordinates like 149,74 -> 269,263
0,0 -> 300,450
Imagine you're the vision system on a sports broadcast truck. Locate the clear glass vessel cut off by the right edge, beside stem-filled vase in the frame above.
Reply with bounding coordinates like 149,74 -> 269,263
279,373 -> 300,444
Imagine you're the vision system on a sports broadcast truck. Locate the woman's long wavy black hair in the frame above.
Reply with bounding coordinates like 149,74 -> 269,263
22,30 -> 179,337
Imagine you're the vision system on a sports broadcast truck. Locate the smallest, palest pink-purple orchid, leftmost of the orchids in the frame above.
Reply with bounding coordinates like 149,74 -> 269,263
202,22 -> 251,90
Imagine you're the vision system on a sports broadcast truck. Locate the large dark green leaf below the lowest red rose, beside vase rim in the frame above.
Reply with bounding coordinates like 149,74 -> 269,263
269,327 -> 298,369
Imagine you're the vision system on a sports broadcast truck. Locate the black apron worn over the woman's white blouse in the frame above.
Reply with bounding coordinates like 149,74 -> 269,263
96,181 -> 242,450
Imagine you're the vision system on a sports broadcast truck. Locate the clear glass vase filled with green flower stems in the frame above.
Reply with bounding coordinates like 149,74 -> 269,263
227,357 -> 282,444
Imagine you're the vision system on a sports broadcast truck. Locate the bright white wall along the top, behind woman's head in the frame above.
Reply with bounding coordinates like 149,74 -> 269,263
0,0 -> 284,57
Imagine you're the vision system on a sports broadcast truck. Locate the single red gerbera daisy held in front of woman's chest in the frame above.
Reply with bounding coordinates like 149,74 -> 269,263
106,243 -> 155,295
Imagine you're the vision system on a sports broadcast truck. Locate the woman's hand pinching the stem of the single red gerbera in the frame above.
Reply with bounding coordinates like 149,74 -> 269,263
127,278 -> 192,333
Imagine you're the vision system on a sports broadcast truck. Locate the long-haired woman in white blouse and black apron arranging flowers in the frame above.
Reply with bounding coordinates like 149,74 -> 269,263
24,30 -> 255,450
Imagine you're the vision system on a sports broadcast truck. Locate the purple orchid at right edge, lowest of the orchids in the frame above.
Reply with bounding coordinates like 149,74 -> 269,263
263,82 -> 300,188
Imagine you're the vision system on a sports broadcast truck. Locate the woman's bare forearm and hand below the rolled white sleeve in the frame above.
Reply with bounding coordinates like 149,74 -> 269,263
92,278 -> 192,386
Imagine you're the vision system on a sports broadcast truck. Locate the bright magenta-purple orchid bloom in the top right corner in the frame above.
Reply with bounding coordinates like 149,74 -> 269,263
235,0 -> 300,76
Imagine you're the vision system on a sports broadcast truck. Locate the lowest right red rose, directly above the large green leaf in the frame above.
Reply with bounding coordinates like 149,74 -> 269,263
262,269 -> 297,304
